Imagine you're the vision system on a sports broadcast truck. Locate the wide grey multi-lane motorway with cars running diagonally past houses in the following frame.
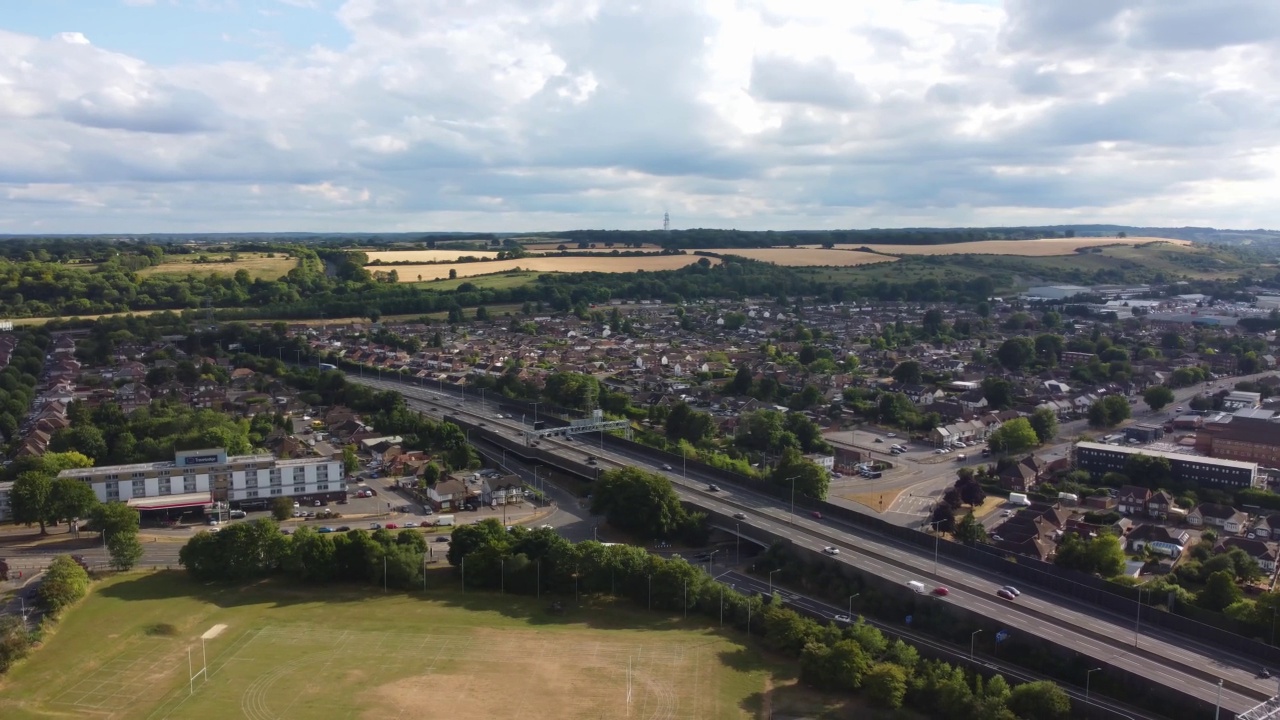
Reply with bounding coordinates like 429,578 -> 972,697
348,375 -> 1274,712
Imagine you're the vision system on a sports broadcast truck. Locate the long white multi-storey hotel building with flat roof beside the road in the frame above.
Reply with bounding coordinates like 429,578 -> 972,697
58,448 -> 347,510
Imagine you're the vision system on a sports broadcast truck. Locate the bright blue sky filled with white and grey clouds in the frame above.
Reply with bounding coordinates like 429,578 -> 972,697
0,0 -> 1280,233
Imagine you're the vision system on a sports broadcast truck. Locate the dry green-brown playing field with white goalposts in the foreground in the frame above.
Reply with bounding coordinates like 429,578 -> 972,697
0,570 -> 849,720
